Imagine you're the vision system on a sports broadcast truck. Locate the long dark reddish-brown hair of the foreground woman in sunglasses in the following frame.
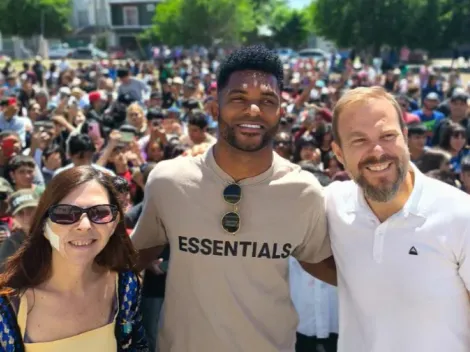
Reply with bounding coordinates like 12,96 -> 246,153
0,166 -> 137,294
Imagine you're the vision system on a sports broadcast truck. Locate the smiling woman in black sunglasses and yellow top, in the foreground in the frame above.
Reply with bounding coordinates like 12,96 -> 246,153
0,166 -> 148,352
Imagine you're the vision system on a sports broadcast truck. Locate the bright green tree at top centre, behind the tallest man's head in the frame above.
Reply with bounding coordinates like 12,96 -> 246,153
147,0 -> 256,46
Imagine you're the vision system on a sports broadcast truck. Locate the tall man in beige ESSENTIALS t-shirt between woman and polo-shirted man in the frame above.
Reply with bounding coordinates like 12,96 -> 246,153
132,46 -> 336,352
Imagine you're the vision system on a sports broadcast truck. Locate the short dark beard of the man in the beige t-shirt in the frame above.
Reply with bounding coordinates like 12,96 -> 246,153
218,116 -> 279,153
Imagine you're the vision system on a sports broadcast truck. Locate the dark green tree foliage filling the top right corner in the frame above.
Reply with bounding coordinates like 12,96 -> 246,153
307,0 -> 470,52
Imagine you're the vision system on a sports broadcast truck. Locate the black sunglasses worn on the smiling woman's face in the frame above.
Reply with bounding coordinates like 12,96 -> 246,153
48,204 -> 119,225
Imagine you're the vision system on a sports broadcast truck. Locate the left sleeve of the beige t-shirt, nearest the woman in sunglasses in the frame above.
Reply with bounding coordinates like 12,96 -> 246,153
131,167 -> 168,250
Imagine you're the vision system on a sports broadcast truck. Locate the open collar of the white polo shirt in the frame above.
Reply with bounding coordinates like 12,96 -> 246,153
346,163 -> 426,218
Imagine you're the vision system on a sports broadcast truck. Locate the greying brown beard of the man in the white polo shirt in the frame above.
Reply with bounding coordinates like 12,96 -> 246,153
354,155 -> 408,203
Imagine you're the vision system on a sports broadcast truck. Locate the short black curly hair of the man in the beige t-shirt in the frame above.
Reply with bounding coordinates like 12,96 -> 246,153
217,45 -> 284,91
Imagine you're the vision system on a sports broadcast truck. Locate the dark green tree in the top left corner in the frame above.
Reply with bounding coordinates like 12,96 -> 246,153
0,0 -> 72,38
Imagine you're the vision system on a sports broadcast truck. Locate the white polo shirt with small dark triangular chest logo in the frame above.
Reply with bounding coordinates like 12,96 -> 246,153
326,167 -> 470,352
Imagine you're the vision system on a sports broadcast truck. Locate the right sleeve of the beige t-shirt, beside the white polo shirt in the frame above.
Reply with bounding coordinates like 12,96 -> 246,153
292,180 -> 333,264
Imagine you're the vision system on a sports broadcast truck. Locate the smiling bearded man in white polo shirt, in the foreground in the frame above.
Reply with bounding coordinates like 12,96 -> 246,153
326,87 -> 470,352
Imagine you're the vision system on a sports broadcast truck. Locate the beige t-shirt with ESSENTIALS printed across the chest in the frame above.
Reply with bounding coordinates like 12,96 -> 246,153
132,148 -> 331,352
